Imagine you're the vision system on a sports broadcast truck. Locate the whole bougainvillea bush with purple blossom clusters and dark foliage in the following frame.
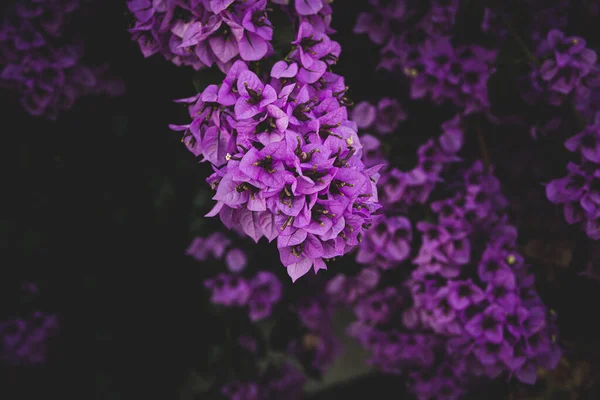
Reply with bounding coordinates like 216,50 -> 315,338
0,0 -> 600,400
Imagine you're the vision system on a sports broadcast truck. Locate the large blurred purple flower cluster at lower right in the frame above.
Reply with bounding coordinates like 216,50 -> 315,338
408,163 -> 561,383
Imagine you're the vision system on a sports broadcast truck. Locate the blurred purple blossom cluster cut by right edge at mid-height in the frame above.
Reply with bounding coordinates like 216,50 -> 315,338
546,112 -> 600,240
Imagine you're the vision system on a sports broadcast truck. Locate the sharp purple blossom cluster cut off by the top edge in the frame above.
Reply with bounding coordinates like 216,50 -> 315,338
127,0 -> 273,72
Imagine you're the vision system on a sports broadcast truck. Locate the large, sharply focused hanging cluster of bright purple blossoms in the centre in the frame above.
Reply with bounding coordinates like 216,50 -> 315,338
173,13 -> 379,281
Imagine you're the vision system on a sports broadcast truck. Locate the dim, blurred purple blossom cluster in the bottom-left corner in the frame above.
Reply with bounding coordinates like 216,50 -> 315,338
0,311 -> 58,365
